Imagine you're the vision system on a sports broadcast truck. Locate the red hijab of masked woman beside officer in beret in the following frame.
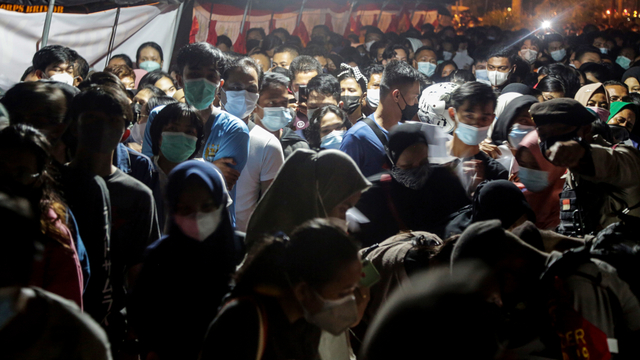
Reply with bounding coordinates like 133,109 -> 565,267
520,131 -> 567,229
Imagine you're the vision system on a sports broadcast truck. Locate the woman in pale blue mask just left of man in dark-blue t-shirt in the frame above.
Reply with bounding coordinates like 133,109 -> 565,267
304,105 -> 351,150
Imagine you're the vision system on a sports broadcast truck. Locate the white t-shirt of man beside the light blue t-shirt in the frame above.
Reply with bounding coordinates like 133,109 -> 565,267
236,126 -> 284,231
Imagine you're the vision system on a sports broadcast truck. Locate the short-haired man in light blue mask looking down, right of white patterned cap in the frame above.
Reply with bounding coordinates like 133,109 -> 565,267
448,82 -> 509,193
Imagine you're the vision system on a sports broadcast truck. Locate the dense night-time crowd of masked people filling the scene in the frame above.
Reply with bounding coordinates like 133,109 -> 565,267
0,17 -> 640,360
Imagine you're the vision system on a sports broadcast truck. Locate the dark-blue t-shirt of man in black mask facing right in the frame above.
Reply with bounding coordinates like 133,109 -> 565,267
340,114 -> 389,177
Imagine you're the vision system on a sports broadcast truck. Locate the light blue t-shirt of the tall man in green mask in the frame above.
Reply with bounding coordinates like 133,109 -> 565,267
202,111 -> 249,227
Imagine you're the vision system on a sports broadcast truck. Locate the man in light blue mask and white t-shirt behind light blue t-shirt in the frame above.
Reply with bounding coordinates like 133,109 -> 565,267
220,57 -> 284,231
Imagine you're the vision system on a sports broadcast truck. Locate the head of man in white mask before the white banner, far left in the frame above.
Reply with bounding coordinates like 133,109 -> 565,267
32,45 -> 74,85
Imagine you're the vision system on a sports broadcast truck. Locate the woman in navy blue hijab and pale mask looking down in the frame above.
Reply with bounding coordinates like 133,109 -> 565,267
127,160 -> 238,360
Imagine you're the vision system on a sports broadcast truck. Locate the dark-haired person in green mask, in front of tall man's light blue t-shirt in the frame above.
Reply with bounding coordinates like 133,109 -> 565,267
149,103 -> 204,231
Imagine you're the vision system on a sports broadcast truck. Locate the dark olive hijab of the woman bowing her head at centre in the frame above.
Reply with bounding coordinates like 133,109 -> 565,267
246,149 -> 371,247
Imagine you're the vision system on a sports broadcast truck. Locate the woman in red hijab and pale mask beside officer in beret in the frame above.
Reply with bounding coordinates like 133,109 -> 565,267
516,130 -> 567,229
